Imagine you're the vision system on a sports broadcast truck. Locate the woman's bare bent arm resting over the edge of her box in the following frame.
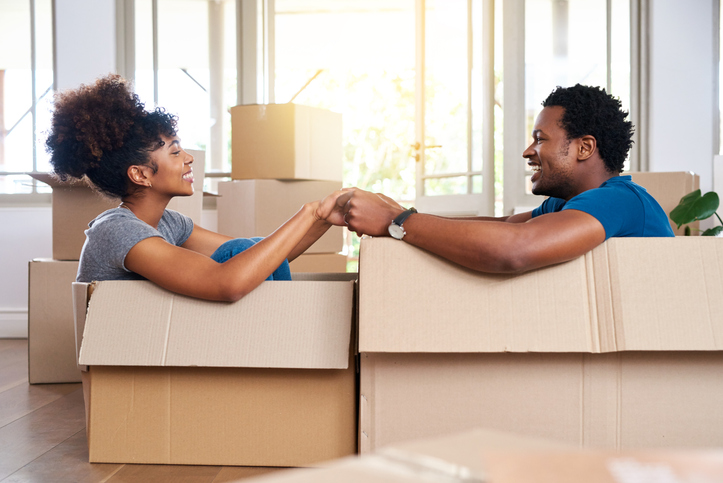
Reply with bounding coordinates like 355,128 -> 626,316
125,202 -> 321,301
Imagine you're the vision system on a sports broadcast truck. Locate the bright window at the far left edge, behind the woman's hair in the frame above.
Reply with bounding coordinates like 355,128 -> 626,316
0,0 -> 53,194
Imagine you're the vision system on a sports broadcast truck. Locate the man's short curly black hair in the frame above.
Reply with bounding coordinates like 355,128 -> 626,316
542,84 -> 635,173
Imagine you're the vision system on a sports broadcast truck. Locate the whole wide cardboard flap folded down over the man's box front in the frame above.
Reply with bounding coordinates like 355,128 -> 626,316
359,237 -> 723,353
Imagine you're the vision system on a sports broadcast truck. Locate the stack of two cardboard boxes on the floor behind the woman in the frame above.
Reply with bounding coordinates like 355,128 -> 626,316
28,150 -> 205,384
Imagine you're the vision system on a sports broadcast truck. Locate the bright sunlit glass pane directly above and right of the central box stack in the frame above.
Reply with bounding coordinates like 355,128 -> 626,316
274,0 -> 415,200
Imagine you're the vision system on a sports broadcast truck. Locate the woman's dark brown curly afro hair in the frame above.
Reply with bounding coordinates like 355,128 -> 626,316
45,75 -> 177,198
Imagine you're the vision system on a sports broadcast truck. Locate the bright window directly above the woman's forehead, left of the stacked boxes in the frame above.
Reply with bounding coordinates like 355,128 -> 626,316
132,0 -> 237,189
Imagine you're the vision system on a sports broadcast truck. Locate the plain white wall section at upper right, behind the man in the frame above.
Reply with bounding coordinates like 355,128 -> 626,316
649,0 -> 718,192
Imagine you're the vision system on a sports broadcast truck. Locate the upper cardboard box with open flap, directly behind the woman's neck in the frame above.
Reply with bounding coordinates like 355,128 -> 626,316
30,150 -> 205,260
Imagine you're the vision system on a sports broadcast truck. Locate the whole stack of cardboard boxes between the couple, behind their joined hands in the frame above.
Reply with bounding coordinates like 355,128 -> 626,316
217,104 -> 346,272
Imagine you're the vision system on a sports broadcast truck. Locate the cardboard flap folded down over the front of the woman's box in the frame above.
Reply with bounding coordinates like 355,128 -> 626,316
80,281 -> 353,369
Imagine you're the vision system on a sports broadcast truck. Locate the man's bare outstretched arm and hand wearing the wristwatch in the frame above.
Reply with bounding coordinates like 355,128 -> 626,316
346,191 -> 605,273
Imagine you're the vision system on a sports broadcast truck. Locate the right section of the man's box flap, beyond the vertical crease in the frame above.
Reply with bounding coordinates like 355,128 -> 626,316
596,237 -> 723,350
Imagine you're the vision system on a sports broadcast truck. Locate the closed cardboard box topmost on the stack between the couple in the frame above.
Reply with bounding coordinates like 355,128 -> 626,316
231,104 -> 343,182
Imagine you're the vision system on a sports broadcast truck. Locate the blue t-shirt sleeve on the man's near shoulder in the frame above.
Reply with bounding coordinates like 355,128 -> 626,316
563,187 -> 645,240
